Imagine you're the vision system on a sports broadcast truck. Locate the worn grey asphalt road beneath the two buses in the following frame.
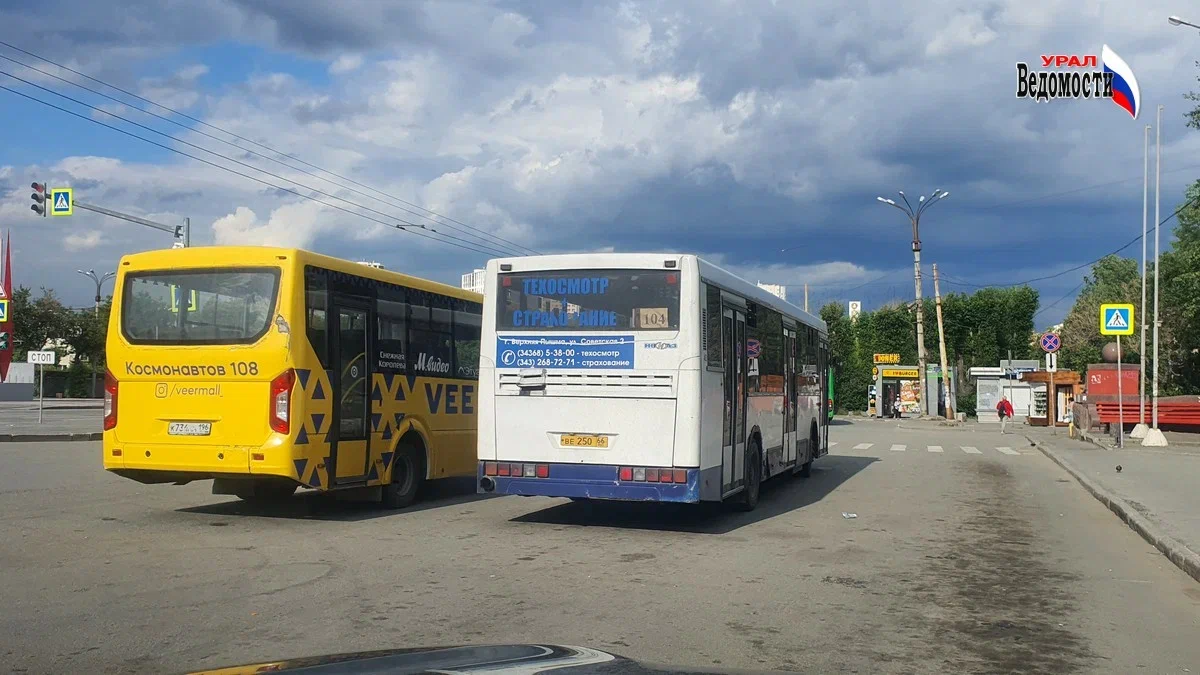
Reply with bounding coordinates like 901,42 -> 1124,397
0,422 -> 1200,674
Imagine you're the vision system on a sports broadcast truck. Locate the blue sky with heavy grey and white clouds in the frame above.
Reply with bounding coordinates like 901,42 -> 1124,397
0,0 -> 1200,328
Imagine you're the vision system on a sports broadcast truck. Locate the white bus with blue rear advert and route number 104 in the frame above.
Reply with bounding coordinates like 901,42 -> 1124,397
479,253 -> 829,509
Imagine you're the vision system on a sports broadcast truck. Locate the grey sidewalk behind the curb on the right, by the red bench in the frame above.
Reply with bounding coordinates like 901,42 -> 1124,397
1024,426 -> 1200,581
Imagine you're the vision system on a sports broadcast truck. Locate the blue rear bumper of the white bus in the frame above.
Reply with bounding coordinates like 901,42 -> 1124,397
476,461 -> 700,503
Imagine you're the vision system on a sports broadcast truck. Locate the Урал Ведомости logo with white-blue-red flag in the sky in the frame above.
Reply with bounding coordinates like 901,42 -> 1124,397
1016,44 -> 1141,119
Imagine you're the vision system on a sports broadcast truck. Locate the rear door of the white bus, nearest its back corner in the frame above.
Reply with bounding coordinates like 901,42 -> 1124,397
721,307 -> 746,494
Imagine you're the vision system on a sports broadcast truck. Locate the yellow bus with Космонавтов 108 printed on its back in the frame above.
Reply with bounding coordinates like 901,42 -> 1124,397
103,246 -> 482,508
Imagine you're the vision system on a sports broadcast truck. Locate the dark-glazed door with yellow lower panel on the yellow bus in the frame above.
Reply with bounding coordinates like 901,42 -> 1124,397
329,294 -> 374,486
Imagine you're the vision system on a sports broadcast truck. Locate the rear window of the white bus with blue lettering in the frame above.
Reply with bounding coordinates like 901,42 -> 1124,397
496,269 -> 679,330
